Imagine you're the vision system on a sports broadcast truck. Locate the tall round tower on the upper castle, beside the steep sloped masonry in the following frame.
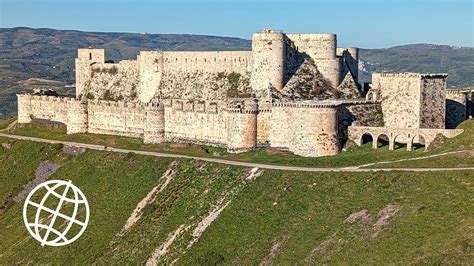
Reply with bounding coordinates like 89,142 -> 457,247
250,30 -> 286,95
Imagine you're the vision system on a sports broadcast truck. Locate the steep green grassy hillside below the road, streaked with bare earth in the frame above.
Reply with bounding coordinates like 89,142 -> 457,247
0,138 -> 474,265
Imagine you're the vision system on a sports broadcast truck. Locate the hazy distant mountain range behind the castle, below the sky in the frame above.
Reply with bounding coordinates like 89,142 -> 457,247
0,27 -> 474,117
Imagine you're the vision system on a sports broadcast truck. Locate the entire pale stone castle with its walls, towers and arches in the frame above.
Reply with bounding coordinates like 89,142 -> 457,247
18,30 -> 472,157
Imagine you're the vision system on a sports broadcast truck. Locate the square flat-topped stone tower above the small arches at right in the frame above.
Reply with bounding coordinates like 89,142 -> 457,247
372,73 -> 448,128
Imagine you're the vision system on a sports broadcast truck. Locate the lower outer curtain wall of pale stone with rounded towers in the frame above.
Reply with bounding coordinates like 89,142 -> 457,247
17,95 -> 346,157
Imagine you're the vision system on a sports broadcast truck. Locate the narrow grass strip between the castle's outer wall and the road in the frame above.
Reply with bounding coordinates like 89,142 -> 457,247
6,119 -> 474,167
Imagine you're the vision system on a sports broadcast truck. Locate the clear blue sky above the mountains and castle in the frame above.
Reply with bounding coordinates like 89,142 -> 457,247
0,0 -> 474,48
